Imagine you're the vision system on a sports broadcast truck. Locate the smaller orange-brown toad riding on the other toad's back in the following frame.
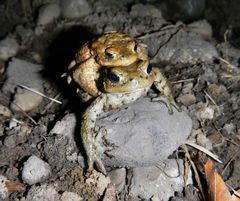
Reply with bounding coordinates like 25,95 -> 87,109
63,31 -> 148,100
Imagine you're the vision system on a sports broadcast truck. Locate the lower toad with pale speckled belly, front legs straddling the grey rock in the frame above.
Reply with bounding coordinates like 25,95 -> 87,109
81,61 -> 180,174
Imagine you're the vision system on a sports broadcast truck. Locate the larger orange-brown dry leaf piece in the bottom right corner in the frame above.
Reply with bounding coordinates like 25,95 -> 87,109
204,160 -> 233,201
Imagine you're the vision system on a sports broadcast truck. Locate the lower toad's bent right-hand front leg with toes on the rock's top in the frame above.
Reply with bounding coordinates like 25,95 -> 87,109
151,67 -> 181,114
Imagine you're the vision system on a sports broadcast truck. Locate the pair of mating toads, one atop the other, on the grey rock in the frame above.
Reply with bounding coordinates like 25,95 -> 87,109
62,32 -> 180,174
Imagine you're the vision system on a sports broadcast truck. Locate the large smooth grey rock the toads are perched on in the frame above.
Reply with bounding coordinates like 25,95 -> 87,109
97,98 -> 192,167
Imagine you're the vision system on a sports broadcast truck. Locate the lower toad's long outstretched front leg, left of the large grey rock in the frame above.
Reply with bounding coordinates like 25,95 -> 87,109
81,94 -> 106,174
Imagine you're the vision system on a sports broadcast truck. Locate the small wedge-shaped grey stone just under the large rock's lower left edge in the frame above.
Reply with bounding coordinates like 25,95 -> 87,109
108,168 -> 126,192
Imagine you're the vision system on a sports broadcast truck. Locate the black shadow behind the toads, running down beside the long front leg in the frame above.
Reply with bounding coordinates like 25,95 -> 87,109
43,26 -> 95,157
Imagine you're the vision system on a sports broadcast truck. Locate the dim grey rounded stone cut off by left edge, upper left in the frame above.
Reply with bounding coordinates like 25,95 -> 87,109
0,36 -> 19,61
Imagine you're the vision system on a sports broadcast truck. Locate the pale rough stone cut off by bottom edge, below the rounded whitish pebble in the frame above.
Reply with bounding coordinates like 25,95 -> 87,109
23,184 -> 60,201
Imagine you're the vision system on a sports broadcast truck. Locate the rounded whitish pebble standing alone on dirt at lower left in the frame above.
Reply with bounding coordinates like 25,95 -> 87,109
22,155 -> 51,185
